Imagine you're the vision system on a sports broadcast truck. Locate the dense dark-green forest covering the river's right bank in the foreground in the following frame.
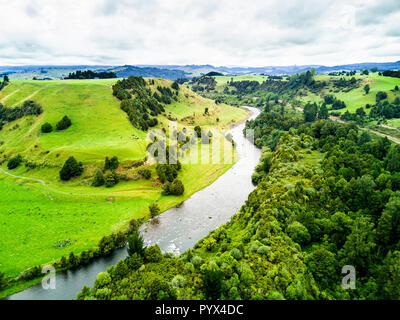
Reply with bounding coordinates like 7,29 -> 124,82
78,100 -> 400,299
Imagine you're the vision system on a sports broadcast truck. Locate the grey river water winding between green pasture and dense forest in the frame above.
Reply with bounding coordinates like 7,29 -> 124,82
7,107 -> 261,300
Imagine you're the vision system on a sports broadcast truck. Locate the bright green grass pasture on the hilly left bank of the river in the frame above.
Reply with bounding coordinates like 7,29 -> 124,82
0,79 -> 248,294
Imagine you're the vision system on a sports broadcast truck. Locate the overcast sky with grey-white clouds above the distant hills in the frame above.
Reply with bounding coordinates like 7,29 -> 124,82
0,0 -> 400,66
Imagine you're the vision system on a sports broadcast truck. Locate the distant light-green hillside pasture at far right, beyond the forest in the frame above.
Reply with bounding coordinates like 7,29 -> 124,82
300,73 -> 400,117
